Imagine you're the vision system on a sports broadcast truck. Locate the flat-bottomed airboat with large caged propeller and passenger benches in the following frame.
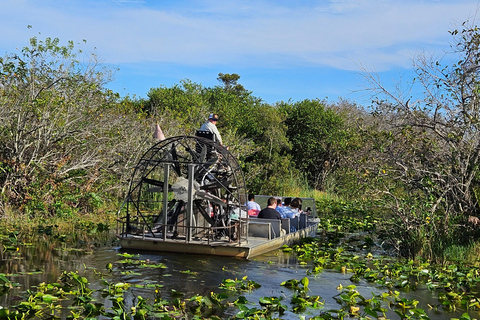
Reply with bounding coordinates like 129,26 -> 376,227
117,133 -> 318,259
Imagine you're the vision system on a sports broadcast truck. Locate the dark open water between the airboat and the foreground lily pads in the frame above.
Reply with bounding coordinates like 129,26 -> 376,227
0,232 -> 478,320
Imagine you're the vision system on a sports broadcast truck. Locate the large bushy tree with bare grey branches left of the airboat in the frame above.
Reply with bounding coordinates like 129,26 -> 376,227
0,37 -> 154,218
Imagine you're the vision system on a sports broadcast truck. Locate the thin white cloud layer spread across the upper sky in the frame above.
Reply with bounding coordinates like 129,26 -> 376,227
0,0 -> 477,71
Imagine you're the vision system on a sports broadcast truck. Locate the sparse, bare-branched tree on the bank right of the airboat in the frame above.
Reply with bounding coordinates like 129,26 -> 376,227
366,22 -> 480,255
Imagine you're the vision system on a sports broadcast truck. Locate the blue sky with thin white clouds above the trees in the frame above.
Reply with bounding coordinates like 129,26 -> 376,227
0,0 -> 480,105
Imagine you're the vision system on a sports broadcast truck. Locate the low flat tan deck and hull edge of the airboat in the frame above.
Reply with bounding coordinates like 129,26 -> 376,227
118,224 -> 317,259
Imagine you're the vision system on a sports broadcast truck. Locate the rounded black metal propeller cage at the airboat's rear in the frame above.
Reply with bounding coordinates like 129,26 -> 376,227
118,136 -> 248,243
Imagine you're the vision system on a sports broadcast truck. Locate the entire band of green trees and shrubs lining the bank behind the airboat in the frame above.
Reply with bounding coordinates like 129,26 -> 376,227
9,24 -> 480,260
